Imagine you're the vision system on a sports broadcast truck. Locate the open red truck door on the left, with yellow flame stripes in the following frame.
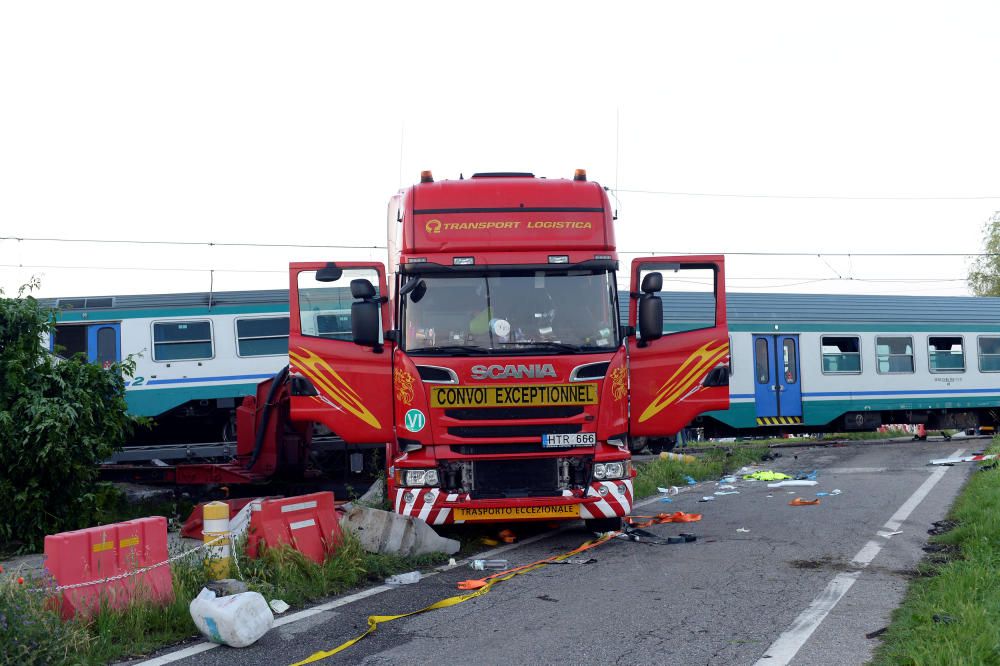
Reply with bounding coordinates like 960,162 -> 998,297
288,261 -> 393,444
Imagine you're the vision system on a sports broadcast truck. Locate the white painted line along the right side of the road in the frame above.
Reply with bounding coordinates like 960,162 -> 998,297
754,449 -> 965,666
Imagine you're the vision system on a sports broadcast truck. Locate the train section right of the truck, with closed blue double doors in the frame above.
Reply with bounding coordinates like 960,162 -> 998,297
664,294 -> 1000,436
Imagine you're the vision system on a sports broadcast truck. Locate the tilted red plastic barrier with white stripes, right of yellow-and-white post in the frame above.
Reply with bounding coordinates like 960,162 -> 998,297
247,492 -> 341,564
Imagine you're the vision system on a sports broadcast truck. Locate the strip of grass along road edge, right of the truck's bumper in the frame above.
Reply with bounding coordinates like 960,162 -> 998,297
633,442 -> 767,499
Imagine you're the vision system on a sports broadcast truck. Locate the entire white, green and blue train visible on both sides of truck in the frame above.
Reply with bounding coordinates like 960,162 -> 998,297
43,290 -> 1000,441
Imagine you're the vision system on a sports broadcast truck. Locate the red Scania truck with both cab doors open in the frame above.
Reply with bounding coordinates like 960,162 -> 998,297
278,170 -> 729,530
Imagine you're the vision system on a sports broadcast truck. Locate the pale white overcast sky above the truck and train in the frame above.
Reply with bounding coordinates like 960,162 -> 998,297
0,0 -> 1000,297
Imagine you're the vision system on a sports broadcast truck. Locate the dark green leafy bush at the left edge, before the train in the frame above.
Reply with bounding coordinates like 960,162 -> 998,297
0,281 -> 138,551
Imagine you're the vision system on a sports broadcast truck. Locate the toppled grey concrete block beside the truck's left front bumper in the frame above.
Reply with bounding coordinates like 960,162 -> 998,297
340,504 -> 461,555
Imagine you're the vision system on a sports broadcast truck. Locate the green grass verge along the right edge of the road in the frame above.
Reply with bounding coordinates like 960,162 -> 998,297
873,438 -> 1000,666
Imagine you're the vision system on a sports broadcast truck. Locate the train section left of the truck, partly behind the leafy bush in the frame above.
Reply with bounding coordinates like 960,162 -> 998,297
42,290 -> 296,441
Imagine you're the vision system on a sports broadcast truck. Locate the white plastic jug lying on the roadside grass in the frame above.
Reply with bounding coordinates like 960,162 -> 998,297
190,588 -> 274,647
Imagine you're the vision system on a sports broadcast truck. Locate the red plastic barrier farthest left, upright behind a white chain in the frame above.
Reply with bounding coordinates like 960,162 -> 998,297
45,516 -> 174,619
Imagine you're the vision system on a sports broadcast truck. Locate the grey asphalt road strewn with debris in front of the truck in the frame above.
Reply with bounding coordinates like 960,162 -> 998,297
145,439 -> 987,666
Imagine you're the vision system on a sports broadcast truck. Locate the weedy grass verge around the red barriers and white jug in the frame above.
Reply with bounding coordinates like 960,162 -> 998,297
0,535 -> 448,664
